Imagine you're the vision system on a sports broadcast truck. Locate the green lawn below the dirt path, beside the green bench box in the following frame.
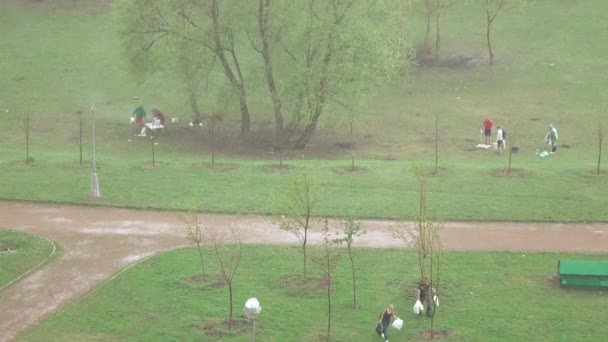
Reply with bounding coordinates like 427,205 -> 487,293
18,245 -> 608,341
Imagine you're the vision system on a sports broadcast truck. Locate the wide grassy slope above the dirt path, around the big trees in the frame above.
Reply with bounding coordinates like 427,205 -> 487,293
0,0 -> 608,221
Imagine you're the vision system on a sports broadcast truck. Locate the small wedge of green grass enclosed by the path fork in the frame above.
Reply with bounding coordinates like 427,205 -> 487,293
0,229 -> 54,288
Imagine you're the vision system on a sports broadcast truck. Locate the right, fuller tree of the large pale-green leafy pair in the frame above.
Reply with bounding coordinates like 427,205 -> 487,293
254,0 -> 412,148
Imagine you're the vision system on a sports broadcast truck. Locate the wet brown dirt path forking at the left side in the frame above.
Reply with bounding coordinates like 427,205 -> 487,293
0,201 -> 608,341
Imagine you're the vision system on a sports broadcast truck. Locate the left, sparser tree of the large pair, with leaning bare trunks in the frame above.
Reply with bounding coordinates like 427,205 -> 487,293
117,0 -> 250,135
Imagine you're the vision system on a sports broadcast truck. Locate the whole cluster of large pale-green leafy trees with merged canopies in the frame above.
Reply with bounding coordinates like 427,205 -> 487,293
118,0 -> 413,148
